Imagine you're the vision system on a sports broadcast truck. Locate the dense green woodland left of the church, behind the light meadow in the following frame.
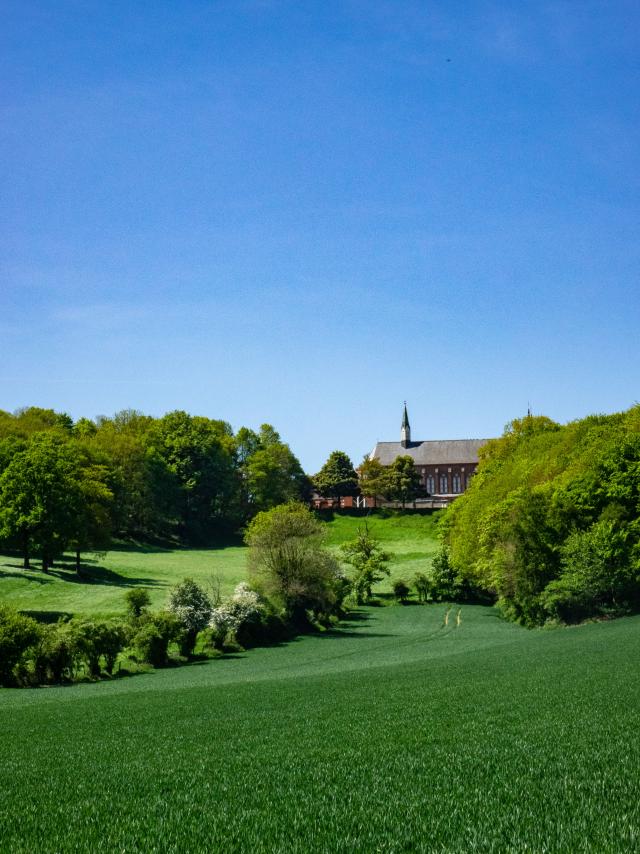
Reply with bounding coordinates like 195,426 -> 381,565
0,407 -> 309,569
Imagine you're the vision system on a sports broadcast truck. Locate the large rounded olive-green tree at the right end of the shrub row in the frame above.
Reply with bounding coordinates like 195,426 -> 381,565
245,503 -> 344,626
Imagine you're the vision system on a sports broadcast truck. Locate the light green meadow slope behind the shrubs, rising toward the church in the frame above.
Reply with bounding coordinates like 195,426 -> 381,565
0,514 -> 437,616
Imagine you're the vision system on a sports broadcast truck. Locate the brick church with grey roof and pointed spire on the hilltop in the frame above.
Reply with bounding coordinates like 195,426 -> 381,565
369,403 -> 489,501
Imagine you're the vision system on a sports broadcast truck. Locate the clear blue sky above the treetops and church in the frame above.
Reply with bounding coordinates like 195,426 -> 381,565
0,0 -> 640,472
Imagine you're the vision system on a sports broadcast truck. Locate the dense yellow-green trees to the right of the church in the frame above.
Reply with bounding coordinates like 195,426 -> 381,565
440,405 -> 640,625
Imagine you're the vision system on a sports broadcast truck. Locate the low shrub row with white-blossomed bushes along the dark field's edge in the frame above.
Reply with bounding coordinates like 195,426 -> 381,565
0,579 -> 291,687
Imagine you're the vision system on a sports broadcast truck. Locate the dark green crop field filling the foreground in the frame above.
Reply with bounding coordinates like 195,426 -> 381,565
0,606 -> 640,854
